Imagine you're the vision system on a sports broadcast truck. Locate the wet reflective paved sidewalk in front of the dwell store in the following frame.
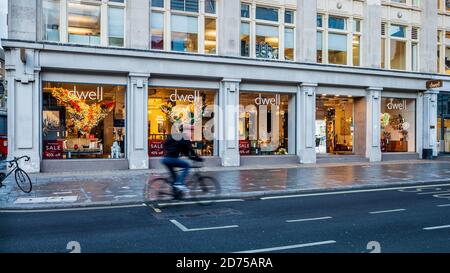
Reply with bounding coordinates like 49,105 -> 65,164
0,160 -> 450,209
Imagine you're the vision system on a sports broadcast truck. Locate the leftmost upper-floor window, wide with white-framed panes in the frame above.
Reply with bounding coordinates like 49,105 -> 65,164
42,0 -> 125,47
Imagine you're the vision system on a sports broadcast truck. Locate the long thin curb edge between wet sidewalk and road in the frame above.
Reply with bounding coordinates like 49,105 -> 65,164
0,179 -> 450,210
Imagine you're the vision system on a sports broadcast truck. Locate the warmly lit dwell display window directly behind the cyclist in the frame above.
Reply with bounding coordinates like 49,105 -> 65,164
148,88 -> 216,157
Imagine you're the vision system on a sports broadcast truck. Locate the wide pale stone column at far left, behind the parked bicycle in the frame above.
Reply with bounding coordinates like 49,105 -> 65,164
6,49 -> 42,172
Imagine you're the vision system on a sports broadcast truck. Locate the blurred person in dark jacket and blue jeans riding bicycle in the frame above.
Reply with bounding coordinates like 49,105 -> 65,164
161,126 -> 203,192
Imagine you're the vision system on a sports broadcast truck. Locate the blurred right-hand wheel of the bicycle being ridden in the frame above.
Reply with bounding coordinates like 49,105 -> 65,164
190,176 -> 220,205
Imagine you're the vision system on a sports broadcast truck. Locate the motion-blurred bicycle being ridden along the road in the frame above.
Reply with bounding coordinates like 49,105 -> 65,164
148,163 -> 221,205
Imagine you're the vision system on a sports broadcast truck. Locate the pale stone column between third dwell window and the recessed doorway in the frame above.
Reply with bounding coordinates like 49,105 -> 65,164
296,83 -> 317,164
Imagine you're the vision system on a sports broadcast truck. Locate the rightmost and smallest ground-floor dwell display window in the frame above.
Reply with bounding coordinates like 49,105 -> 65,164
381,98 -> 416,152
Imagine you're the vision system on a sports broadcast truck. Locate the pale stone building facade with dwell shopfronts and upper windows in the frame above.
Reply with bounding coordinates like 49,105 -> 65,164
3,0 -> 450,172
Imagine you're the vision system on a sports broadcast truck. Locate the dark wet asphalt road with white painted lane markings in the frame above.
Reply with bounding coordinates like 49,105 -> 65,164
0,182 -> 450,253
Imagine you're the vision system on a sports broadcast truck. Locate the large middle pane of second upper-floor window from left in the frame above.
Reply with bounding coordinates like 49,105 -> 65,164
171,15 -> 198,52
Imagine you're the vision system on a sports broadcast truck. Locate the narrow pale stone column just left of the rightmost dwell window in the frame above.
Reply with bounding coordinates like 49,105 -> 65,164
366,87 -> 383,162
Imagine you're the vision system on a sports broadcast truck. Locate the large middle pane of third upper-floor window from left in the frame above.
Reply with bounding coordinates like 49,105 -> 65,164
256,24 -> 279,59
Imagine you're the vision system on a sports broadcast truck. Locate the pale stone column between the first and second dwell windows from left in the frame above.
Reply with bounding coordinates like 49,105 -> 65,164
127,73 -> 150,170
